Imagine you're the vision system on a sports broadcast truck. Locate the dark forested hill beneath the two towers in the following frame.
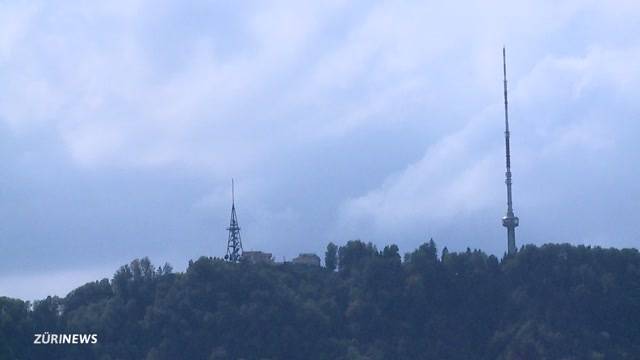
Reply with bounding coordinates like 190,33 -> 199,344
0,241 -> 640,360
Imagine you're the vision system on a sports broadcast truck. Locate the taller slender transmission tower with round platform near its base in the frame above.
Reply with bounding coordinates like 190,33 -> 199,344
502,47 -> 520,255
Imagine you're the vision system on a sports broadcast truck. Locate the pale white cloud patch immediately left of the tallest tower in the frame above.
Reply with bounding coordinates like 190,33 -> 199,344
343,108 -> 500,228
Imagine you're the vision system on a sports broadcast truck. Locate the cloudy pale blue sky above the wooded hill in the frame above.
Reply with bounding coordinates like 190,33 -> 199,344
0,0 -> 640,300
